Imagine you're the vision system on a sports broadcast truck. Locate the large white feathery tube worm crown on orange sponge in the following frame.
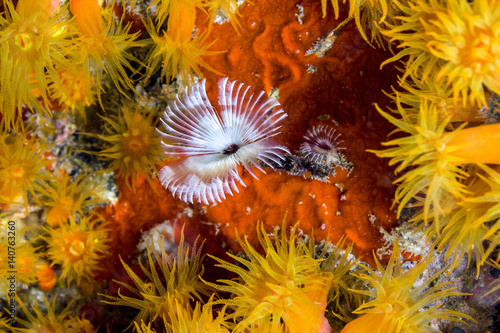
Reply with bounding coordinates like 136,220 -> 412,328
158,77 -> 289,205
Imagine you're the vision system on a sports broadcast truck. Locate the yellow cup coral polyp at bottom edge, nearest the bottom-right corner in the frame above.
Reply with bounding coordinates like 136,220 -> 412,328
341,241 -> 472,333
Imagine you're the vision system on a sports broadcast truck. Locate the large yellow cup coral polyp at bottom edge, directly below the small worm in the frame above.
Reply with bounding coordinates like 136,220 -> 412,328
207,219 -> 333,333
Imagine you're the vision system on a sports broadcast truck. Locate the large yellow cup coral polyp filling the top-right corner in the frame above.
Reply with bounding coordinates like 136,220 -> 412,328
382,0 -> 500,106
